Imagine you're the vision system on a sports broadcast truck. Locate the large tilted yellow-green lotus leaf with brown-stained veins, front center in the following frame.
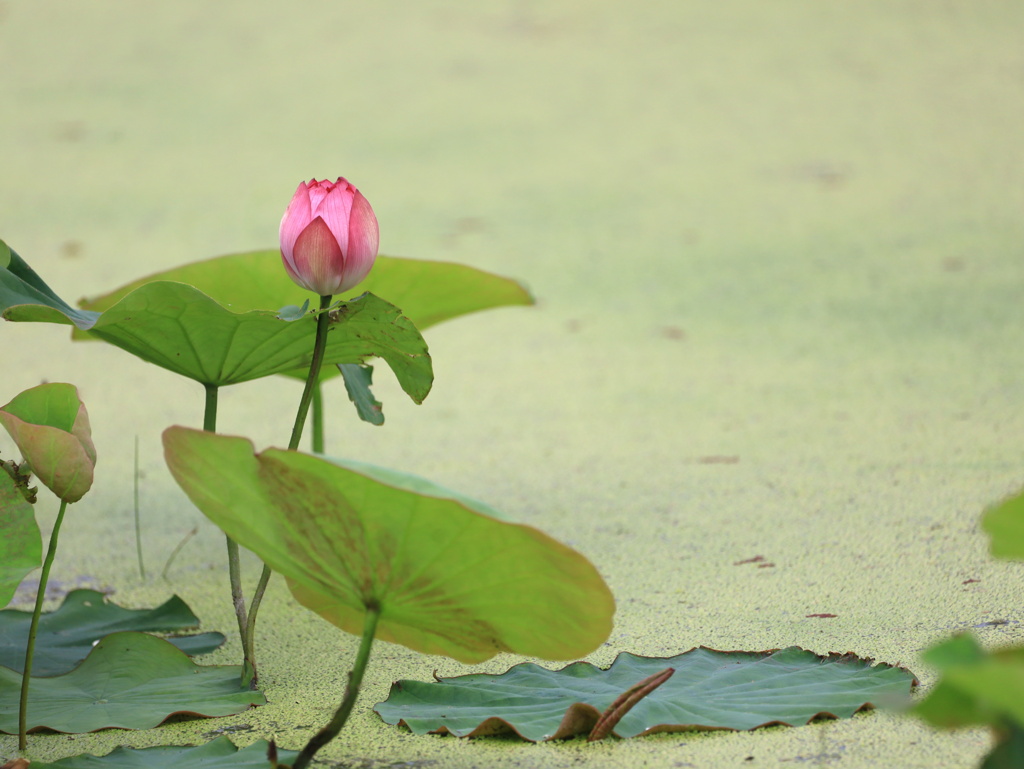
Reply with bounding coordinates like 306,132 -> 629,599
164,427 -> 614,663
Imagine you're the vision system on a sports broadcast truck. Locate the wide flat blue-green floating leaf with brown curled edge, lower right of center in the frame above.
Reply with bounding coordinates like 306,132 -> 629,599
374,646 -> 916,742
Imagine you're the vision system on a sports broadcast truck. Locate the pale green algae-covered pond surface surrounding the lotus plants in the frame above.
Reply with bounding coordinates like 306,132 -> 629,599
0,0 -> 1024,769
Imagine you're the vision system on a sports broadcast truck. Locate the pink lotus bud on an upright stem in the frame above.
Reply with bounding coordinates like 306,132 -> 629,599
281,177 -> 380,296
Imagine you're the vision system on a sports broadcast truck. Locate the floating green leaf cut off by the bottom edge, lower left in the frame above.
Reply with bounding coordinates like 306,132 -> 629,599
32,737 -> 299,769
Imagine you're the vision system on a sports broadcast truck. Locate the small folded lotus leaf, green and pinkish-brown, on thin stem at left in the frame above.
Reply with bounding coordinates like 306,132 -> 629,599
0,383 -> 96,503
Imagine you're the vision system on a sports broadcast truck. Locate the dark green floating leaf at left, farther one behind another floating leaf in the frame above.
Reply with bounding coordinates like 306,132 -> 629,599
0,590 -> 224,676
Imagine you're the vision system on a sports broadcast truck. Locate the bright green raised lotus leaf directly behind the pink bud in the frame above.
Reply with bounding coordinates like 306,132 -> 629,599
76,249 -> 534,337
